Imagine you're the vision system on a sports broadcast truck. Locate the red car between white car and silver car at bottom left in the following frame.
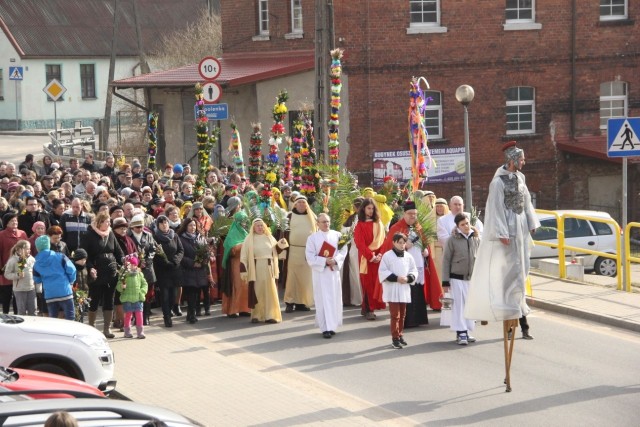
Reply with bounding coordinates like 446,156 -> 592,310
0,366 -> 104,399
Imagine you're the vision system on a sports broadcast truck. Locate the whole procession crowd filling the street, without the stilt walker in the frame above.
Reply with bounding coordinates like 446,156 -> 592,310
0,142 -> 530,349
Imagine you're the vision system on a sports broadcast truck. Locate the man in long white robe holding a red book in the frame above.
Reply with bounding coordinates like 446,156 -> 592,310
305,213 -> 347,338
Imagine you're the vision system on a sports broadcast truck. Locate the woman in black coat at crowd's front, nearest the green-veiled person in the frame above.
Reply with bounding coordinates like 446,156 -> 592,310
178,217 -> 209,324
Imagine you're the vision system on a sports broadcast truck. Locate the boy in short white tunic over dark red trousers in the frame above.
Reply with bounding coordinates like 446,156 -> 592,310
378,233 -> 418,350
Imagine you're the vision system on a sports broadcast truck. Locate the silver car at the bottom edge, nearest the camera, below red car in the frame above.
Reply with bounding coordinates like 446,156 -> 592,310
0,400 -> 200,427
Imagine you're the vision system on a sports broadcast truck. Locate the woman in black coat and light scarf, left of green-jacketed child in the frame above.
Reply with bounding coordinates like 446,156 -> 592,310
80,212 -> 124,338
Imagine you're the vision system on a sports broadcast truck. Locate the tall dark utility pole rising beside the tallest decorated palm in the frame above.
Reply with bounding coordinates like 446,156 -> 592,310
313,0 -> 334,158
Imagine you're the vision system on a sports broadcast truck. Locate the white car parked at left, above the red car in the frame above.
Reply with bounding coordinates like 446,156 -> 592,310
0,314 -> 116,392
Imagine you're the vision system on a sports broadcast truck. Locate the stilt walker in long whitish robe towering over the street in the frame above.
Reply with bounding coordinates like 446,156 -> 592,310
465,141 -> 540,391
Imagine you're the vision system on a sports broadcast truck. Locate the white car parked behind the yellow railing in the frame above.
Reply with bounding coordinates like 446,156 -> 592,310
530,210 -> 618,276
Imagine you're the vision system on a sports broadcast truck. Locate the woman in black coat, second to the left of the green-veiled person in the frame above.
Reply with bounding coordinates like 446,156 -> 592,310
153,215 -> 184,328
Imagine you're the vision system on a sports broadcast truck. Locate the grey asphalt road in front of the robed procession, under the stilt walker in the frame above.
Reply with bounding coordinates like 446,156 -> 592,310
170,308 -> 640,426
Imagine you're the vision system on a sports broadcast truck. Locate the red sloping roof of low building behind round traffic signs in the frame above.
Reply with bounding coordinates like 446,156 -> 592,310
110,51 -> 315,89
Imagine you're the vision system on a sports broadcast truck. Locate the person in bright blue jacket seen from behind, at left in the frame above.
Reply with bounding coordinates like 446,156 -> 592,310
33,234 -> 76,320
